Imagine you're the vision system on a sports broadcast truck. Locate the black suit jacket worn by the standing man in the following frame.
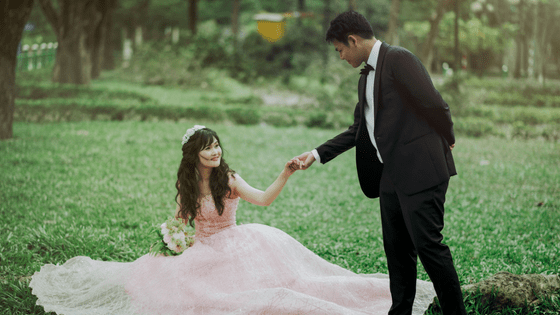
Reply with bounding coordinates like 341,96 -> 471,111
317,43 -> 457,198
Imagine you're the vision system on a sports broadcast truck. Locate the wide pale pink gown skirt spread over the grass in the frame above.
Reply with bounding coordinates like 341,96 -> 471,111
30,224 -> 435,315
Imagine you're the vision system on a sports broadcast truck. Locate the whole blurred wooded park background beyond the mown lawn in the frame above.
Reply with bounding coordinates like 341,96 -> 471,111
1,0 -> 560,141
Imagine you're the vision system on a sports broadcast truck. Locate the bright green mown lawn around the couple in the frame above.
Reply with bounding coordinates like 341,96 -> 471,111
0,121 -> 560,314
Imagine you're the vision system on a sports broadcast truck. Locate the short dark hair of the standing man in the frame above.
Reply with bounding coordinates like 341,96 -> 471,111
325,10 -> 373,46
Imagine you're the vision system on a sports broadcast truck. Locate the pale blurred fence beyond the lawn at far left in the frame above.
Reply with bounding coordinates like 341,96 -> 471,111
16,43 -> 58,71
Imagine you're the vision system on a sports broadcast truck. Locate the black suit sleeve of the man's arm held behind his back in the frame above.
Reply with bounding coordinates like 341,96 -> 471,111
389,49 -> 455,144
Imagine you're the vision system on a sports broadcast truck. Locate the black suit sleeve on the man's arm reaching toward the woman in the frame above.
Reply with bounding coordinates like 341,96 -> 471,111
316,103 -> 361,164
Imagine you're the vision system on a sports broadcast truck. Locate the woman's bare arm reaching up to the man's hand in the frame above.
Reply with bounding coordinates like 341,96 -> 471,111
232,158 -> 303,206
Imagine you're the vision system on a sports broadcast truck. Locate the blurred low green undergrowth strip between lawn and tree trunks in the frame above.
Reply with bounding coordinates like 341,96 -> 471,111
14,66 -> 560,141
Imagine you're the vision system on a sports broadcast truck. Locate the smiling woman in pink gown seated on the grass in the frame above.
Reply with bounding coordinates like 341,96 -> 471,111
30,125 -> 435,315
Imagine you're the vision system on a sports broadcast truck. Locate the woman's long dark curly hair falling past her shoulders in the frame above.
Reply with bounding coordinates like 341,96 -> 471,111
175,128 -> 235,227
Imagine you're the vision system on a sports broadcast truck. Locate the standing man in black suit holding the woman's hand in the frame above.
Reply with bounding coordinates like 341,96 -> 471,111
298,11 -> 466,315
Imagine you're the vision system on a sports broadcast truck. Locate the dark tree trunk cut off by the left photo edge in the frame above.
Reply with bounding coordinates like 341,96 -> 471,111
0,0 -> 33,140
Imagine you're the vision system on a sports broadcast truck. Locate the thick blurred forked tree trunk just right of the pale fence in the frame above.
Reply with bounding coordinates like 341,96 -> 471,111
39,0 -> 101,84
